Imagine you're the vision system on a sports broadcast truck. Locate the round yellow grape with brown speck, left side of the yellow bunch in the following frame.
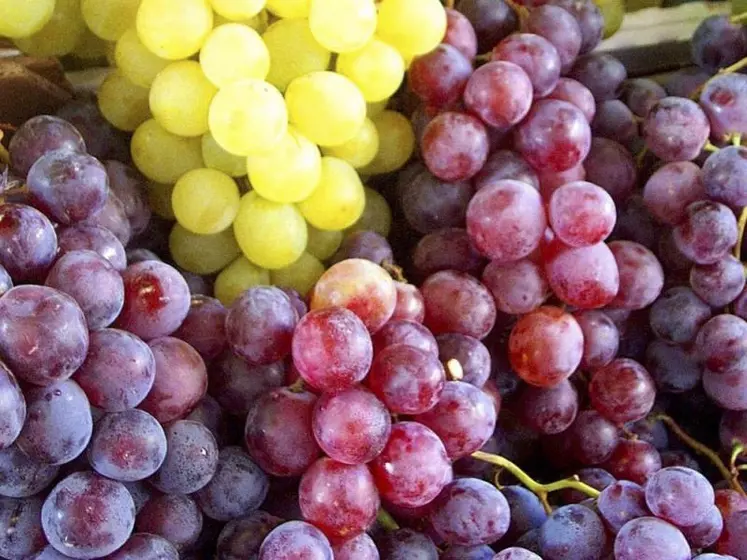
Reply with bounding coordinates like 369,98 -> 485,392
171,169 -> 241,235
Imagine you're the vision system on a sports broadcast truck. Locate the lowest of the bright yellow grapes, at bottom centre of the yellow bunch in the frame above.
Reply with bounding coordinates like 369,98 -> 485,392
233,192 -> 308,269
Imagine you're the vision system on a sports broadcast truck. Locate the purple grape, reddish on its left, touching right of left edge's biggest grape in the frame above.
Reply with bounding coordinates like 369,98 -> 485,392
75,329 -> 156,412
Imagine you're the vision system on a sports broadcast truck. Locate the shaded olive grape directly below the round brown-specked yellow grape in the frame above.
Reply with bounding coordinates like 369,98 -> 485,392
169,224 -> 241,276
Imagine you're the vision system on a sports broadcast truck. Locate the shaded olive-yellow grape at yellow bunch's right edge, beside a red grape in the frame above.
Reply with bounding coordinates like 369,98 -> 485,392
361,111 -> 415,175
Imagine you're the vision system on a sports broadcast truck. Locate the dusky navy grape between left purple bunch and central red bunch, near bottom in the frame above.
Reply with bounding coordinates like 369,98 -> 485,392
195,446 -> 268,521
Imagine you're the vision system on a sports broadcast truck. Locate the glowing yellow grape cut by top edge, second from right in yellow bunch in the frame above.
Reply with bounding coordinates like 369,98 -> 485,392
309,0 -> 376,53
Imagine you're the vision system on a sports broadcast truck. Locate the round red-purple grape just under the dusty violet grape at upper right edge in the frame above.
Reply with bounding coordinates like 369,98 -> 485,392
673,200 -> 737,264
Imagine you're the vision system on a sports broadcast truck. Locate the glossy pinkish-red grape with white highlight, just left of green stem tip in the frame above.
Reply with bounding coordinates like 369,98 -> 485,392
370,422 -> 453,510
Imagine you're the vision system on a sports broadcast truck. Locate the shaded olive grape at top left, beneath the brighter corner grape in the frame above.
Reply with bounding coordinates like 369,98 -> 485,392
14,0 -> 86,56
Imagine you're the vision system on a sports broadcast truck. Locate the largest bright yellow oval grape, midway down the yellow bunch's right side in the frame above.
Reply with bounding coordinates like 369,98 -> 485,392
285,72 -> 366,146
